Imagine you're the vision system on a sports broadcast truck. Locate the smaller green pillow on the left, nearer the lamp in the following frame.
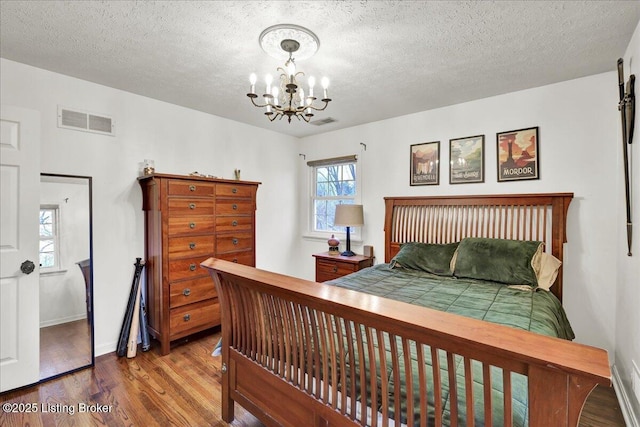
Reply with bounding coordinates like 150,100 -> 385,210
389,242 -> 458,276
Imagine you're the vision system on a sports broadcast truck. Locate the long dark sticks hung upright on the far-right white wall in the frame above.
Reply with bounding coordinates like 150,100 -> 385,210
618,58 -> 636,256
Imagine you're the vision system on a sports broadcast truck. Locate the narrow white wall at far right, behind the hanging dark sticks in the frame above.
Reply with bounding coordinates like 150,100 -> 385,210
615,17 -> 640,422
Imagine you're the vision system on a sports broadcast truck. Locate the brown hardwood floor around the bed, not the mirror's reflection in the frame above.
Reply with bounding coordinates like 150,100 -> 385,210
0,332 -> 625,427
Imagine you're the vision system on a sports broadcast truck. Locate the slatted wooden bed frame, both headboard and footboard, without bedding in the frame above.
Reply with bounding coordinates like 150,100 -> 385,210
202,193 -> 611,427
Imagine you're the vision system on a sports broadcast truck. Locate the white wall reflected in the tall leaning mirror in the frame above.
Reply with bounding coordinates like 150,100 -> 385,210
40,180 -> 90,327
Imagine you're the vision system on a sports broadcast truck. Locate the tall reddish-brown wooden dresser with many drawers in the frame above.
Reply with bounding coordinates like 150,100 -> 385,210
138,173 -> 260,355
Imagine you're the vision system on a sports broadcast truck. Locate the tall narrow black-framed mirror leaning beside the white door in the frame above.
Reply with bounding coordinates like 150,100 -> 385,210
39,173 -> 94,380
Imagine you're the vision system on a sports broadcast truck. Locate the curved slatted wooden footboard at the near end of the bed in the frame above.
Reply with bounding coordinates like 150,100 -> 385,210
202,258 -> 611,427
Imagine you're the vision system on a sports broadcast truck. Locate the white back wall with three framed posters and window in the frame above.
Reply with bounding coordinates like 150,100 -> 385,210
298,72 -> 619,361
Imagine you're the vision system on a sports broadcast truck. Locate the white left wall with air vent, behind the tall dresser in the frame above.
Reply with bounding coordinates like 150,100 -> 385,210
0,59 -> 298,355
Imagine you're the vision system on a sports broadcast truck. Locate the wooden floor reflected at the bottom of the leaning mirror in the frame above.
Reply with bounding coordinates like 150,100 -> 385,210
40,319 -> 91,379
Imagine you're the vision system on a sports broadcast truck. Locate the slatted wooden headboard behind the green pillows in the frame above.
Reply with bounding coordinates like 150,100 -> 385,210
384,193 -> 573,301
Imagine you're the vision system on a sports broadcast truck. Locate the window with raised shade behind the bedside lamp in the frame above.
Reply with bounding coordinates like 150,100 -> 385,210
307,156 -> 357,232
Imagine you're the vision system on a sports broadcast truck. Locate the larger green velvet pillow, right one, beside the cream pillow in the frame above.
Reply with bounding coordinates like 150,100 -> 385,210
453,237 -> 543,287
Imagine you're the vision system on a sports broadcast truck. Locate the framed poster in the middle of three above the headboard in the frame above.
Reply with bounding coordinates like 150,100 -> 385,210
449,135 -> 484,184
